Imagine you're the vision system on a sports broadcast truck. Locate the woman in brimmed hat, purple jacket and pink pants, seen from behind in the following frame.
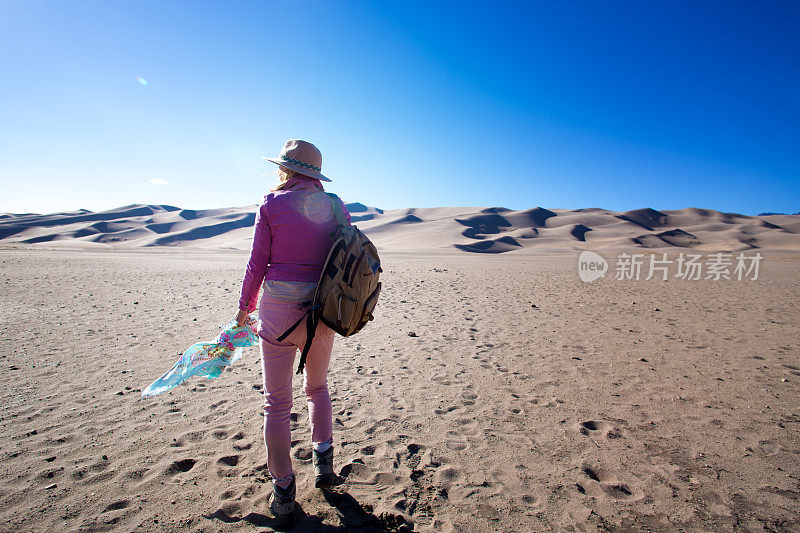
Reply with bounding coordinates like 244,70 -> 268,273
236,140 -> 350,526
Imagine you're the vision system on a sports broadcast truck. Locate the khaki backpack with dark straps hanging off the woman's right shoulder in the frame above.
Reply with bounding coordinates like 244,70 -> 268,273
276,193 -> 383,374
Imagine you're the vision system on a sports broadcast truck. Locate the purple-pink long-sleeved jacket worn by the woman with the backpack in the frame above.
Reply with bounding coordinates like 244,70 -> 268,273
239,177 -> 350,313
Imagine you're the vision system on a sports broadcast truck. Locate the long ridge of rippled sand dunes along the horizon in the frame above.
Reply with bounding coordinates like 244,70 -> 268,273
0,203 -> 800,254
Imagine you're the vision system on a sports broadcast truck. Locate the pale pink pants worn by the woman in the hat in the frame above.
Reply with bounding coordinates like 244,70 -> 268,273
258,294 -> 334,481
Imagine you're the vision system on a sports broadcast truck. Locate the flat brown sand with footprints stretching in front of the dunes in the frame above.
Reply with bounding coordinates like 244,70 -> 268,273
0,247 -> 800,532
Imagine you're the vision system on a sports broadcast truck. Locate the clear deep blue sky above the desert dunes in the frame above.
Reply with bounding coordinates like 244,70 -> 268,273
0,0 -> 800,214
